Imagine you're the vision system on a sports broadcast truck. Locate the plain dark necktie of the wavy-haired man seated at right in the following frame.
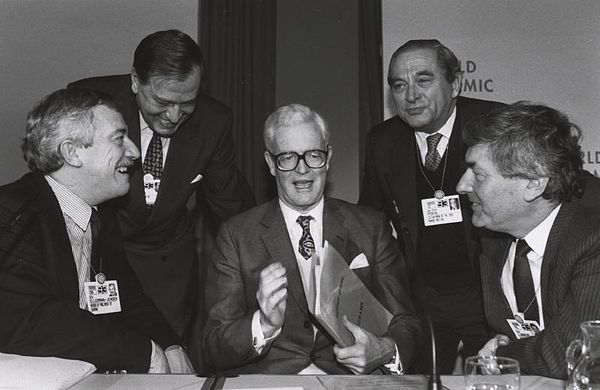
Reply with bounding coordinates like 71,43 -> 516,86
513,240 -> 540,323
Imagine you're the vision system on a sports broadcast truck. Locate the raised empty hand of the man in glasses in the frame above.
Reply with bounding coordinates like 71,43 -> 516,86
256,263 -> 287,338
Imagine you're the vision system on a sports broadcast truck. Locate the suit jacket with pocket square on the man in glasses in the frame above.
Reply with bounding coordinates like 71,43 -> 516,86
204,198 -> 419,374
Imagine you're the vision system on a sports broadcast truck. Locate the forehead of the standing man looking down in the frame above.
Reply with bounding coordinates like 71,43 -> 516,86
144,69 -> 200,102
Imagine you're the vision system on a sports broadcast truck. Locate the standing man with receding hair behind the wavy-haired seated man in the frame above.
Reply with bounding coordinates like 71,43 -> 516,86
359,40 -> 500,374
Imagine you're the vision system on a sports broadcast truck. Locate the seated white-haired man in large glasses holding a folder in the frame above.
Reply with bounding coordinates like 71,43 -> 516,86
204,104 -> 419,374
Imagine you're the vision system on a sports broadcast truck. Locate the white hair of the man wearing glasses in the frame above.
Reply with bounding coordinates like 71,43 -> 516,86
263,104 -> 329,151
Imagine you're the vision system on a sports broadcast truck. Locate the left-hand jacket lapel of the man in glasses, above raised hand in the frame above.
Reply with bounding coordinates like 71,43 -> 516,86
261,198 -> 309,316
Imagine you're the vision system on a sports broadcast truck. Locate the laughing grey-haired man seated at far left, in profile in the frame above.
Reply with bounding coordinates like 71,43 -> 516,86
0,90 -> 192,373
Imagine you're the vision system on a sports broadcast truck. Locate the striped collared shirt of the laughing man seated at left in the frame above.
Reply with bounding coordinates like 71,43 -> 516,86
44,175 -> 92,309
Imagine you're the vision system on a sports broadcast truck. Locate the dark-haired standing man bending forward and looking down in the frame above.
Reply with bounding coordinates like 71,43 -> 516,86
69,30 -> 254,340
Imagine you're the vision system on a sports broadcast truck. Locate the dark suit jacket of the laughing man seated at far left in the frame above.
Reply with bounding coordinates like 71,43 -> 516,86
0,173 -> 179,373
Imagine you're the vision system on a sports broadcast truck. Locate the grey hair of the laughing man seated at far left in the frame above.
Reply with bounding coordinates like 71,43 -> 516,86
21,89 -> 118,174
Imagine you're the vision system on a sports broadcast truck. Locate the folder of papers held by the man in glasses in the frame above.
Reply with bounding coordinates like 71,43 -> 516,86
309,241 -> 393,347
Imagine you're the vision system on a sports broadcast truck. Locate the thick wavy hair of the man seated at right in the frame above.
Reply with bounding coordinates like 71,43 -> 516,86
463,102 -> 583,202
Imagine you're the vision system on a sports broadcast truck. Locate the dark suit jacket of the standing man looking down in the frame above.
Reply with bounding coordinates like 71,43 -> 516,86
69,75 -> 254,335
